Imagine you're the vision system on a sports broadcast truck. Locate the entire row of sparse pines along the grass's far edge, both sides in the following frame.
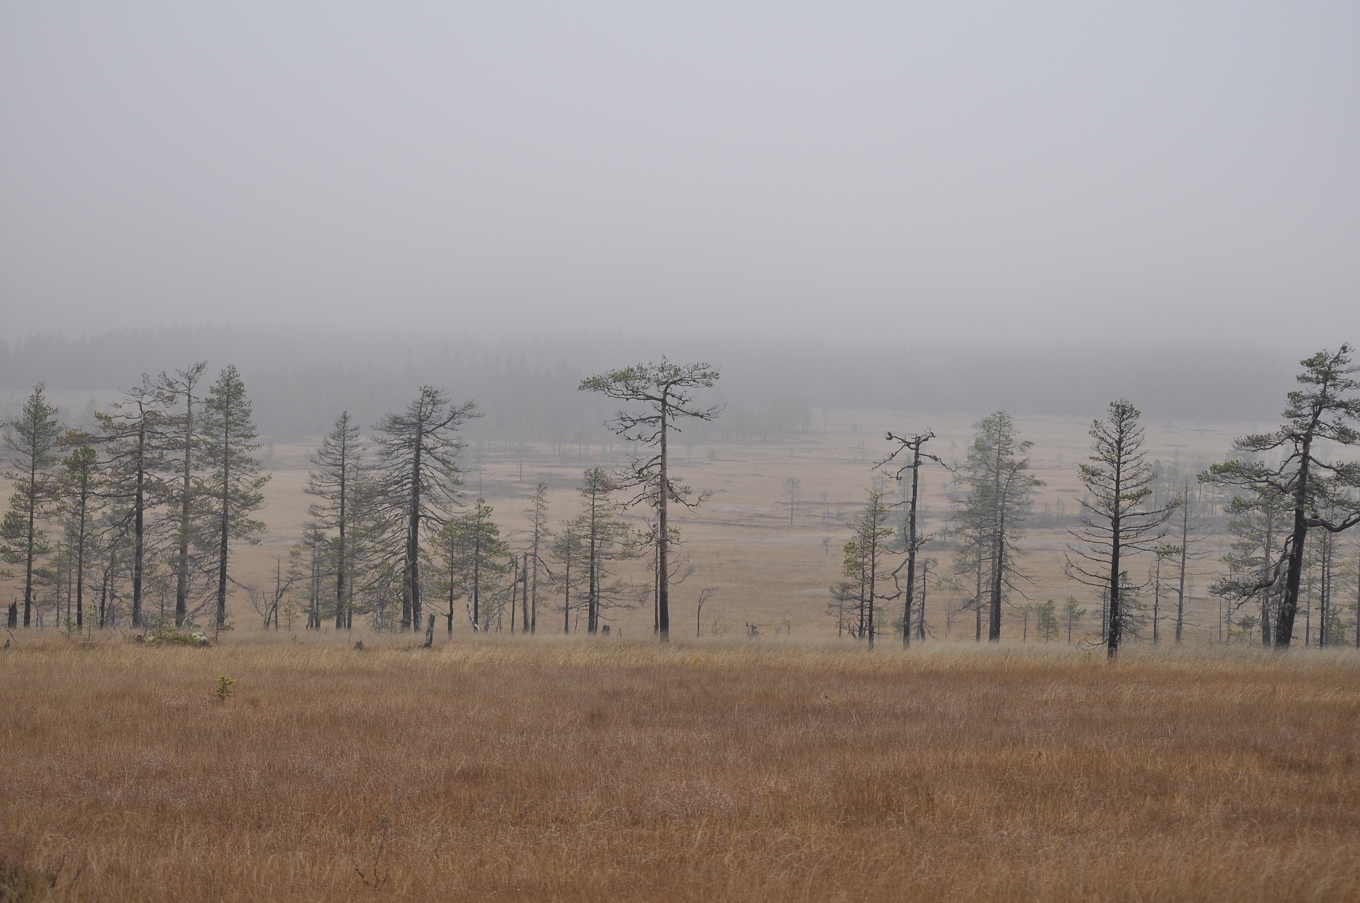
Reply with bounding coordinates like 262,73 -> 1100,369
0,345 -> 1360,657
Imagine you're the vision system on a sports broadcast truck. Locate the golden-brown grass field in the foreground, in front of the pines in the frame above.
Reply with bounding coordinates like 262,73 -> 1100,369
0,635 -> 1360,902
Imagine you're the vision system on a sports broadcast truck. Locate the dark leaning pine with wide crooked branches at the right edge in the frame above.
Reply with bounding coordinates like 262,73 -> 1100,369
1200,344 -> 1360,649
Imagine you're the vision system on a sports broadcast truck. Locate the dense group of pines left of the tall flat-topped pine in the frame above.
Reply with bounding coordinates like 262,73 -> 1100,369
0,363 -> 656,634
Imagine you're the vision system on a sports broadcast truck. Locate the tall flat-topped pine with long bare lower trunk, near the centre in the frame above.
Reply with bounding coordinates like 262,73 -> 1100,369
578,358 -> 722,643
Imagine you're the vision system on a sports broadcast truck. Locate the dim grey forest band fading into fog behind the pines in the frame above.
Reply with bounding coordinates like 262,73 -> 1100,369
0,326 -> 1294,443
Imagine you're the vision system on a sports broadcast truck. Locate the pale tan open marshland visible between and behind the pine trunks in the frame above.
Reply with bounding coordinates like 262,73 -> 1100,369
206,411 -> 1278,642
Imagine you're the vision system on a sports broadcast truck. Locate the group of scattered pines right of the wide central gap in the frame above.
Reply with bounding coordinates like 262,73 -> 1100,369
827,344 -> 1360,658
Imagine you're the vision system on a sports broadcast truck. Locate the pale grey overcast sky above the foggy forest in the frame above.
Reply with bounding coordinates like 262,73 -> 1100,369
0,0 -> 1360,348
